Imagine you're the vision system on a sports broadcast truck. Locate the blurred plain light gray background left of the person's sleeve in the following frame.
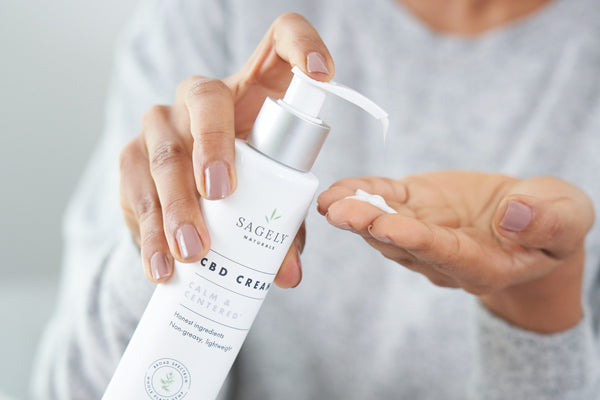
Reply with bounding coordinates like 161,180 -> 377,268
0,0 -> 136,399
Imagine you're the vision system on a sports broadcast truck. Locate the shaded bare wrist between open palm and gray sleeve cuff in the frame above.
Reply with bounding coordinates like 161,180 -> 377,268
479,249 -> 584,334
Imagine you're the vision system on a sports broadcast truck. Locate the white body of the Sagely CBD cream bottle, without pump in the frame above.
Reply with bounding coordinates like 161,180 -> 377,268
103,140 -> 318,400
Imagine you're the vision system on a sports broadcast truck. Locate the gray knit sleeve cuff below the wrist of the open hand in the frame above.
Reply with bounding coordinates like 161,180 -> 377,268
470,302 -> 600,400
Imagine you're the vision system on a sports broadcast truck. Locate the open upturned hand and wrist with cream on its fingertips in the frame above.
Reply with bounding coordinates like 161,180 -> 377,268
318,171 -> 594,333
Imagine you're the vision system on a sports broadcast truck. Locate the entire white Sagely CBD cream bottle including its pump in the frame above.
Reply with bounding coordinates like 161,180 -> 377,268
103,67 -> 388,400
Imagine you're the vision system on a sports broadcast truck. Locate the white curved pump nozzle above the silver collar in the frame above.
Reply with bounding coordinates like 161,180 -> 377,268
283,67 -> 389,137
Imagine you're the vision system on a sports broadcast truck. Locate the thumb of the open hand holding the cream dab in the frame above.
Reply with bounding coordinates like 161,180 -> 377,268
494,177 -> 594,259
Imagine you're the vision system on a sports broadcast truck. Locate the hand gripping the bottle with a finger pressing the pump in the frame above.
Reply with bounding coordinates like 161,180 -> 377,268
120,14 -> 334,287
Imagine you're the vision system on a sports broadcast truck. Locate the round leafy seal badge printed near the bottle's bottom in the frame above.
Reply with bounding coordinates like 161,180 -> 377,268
144,358 -> 191,400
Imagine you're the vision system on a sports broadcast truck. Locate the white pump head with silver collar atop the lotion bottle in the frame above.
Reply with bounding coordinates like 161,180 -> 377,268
248,67 -> 389,171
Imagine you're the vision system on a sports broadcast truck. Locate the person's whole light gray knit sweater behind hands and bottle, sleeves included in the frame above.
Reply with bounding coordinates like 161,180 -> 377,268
33,0 -> 600,400
